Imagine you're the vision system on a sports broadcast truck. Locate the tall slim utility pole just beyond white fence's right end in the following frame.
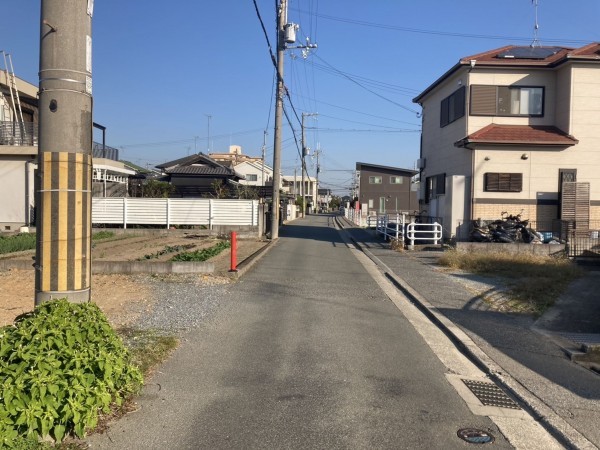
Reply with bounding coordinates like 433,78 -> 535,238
271,0 -> 287,240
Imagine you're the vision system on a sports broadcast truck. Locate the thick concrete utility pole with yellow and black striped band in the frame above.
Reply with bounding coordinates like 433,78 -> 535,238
35,0 -> 93,305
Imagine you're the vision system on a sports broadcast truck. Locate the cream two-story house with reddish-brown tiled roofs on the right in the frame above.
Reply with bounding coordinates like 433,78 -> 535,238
413,43 -> 600,237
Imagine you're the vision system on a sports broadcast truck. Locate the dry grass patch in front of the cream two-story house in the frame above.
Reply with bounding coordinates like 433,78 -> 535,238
438,250 -> 583,316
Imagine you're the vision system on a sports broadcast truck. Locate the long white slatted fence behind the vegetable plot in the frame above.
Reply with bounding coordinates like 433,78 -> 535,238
92,197 -> 259,229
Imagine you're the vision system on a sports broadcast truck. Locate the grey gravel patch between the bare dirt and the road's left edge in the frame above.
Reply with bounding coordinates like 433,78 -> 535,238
127,275 -> 232,334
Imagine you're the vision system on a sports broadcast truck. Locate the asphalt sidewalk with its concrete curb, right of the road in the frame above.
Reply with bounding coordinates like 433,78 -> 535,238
342,219 -> 600,448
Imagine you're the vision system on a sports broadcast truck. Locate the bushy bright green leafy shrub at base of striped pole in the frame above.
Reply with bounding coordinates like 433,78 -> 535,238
0,300 -> 143,447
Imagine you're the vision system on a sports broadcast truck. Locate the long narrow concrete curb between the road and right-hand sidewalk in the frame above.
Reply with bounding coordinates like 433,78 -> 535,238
350,232 -> 597,449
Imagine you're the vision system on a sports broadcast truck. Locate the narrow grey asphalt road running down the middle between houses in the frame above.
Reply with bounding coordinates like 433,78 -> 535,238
87,215 -> 551,449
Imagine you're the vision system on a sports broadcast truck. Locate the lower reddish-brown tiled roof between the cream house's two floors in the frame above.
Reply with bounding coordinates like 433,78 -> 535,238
454,124 -> 579,147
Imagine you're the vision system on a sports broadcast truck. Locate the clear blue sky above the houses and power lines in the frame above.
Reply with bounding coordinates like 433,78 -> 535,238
0,0 -> 600,194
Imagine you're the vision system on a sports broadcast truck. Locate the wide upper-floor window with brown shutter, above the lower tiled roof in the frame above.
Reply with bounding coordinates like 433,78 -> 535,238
471,85 -> 544,117
